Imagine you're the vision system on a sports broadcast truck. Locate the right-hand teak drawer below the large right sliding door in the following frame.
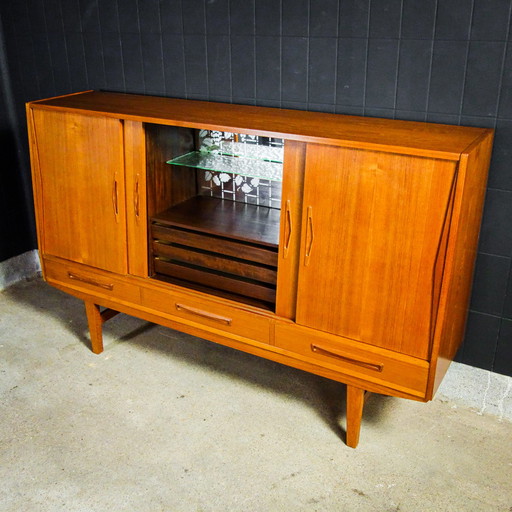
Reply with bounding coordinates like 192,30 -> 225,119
275,323 -> 429,398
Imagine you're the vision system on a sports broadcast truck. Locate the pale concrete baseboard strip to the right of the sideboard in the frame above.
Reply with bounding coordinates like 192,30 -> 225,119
435,362 -> 512,421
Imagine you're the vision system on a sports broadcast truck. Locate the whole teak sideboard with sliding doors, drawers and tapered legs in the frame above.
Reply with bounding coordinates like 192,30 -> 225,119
27,91 -> 493,447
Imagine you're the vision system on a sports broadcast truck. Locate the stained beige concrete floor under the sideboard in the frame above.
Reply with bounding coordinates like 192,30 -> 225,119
0,280 -> 512,512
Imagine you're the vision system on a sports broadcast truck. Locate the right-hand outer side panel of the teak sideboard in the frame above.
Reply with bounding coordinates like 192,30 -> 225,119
427,131 -> 493,399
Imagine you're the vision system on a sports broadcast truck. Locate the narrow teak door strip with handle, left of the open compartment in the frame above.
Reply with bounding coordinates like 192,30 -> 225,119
124,121 -> 148,277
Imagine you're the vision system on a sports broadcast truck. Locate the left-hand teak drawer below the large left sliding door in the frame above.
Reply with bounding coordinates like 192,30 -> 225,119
44,258 -> 140,304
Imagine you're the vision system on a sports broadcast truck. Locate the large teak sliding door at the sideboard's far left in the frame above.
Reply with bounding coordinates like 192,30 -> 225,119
34,109 -> 127,273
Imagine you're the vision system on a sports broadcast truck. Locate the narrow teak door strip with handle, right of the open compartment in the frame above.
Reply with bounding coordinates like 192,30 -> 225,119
276,141 -> 306,320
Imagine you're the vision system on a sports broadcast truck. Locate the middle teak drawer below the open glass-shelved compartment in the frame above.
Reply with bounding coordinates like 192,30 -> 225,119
141,288 -> 270,343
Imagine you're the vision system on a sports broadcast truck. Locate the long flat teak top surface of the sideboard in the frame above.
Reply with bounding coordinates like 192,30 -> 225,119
30,91 -> 492,160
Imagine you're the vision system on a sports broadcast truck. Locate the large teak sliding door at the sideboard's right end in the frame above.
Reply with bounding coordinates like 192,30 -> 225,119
297,145 -> 456,358
